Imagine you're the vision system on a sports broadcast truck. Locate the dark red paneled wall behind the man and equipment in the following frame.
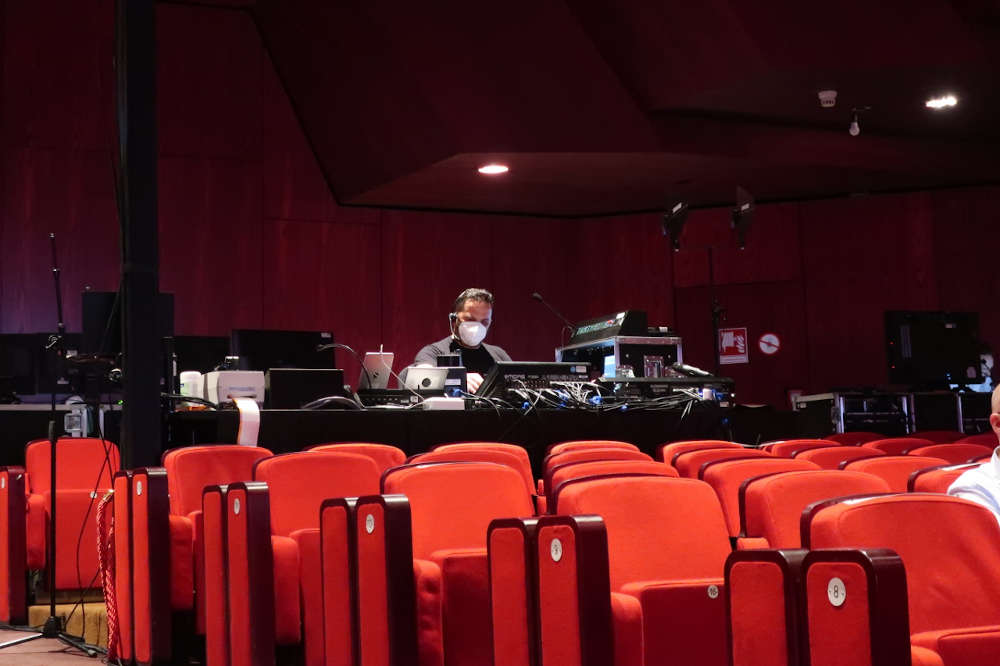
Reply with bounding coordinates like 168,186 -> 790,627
0,0 -> 1000,404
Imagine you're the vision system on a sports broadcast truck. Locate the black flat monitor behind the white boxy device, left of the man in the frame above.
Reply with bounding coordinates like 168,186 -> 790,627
231,328 -> 336,372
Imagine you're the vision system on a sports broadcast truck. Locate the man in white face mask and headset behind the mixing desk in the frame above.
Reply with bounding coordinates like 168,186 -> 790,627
413,289 -> 510,393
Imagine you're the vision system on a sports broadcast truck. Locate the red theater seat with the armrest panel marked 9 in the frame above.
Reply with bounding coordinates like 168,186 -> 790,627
534,476 -> 730,666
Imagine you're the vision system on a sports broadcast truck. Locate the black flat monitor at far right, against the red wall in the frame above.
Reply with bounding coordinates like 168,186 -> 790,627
885,310 -> 983,388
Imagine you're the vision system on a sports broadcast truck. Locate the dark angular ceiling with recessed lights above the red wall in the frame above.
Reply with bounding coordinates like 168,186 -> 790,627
252,0 -> 1000,216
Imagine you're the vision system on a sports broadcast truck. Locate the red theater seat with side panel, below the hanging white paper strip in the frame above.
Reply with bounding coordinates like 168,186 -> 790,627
114,444 -> 271,663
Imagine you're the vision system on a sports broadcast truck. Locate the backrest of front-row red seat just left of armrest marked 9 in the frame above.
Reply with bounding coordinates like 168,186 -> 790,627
382,462 -> 534,559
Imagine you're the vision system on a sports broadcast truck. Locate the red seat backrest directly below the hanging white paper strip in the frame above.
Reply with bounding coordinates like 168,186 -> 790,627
163,444 -> 271,516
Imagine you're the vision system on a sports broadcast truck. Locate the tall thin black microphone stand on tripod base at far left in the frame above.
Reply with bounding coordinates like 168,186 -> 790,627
0,233 -> 98,657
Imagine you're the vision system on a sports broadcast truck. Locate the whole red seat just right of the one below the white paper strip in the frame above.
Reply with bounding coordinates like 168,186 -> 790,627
227,451 -> 380,666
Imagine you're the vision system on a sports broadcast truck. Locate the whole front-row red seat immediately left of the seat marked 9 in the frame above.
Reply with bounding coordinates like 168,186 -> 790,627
357,462 -> 533,665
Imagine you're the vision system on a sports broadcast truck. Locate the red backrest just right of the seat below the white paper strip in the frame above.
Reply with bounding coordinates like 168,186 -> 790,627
253,451 -> 381,536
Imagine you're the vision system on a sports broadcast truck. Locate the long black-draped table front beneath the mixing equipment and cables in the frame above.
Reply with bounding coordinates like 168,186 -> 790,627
168,403 -> 730,475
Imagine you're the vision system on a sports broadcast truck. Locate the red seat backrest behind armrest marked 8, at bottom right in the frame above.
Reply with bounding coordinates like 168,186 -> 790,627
803,493 -> 1000,634
